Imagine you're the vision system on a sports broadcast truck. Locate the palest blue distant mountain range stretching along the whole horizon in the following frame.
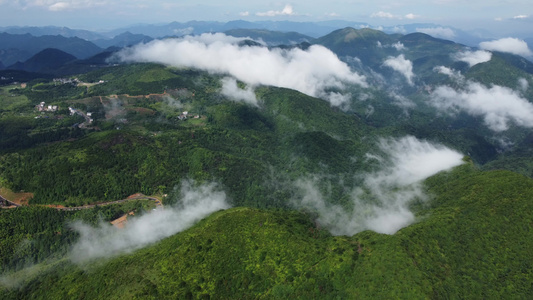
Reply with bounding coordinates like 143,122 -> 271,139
0,20 -> 533,48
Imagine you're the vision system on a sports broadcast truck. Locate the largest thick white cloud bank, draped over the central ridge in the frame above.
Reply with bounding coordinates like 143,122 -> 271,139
117,34 -> 367,105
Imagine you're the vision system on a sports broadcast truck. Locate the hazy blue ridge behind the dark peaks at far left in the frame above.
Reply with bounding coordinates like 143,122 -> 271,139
0,33 -> 102,65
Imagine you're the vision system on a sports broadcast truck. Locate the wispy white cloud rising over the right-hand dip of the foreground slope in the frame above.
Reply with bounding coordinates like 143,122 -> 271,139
293,136 -> 463,236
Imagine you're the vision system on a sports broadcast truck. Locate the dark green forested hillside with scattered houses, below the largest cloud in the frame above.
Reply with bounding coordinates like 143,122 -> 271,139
0,64 -> 373,207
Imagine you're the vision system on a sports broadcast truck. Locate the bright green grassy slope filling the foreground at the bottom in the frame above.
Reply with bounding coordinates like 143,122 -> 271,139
4,165 -> 533,299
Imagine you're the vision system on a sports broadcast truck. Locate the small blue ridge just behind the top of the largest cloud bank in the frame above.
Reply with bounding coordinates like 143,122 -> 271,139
224,29 -> 313,46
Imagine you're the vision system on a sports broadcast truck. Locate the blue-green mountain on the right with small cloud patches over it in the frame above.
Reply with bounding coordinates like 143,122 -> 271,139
314,28 -> 533,169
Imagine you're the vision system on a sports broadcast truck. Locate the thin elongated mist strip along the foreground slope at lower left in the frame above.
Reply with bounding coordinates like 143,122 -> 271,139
70,181 -> 229,263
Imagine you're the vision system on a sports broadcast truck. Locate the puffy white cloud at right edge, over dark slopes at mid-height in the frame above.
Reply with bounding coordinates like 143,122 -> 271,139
431,82 -> 533,132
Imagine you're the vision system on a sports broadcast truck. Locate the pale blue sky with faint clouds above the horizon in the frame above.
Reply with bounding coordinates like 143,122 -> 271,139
0,0 -> 533,32
